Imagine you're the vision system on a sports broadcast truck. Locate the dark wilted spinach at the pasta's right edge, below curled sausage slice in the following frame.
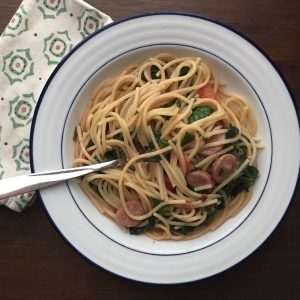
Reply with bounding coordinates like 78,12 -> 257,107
223,166 -> 259,197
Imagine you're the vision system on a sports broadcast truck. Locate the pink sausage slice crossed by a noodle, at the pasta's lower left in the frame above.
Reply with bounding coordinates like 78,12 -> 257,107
115,200 -> 145,227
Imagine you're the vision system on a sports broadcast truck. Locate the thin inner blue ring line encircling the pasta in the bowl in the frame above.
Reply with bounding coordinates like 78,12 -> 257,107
60,43 -> 273,256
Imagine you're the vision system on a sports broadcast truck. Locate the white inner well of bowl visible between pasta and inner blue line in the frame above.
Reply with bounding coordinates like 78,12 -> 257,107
61,44 -> 272,255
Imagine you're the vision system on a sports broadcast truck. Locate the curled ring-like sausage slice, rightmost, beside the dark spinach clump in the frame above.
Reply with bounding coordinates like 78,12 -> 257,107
212,153 -> 238,183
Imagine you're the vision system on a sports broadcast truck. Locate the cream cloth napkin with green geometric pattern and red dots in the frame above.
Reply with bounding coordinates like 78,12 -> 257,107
0,0 -> 112,212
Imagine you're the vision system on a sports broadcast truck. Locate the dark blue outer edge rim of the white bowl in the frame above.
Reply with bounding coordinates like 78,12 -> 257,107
30,11 -> 299,285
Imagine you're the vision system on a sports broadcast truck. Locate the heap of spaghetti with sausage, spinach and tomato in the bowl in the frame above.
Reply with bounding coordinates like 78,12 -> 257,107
74,53 -> 260,240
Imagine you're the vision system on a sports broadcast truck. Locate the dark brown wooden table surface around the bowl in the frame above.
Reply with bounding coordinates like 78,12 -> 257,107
0,0 -> 300,299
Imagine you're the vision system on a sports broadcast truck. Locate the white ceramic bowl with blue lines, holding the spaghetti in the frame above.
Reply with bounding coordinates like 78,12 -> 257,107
31,13 -> 300,283
